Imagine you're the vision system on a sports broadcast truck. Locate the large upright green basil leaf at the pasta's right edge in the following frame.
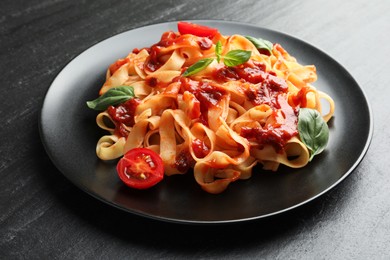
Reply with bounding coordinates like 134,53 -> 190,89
298,108 -> 329,161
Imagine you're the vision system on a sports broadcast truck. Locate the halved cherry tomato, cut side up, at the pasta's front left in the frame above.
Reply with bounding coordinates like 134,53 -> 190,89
116,148 -> 164,189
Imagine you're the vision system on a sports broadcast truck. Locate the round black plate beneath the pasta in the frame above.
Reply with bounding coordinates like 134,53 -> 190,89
40,21 -> 373,224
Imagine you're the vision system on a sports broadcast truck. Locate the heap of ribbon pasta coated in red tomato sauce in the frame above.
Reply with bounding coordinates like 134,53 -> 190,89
90,24 -> 335,193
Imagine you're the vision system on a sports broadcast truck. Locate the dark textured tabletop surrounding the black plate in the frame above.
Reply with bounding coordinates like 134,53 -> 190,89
0,0 -> 390,259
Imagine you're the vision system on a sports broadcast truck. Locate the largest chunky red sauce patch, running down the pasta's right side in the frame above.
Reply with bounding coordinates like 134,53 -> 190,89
214,61 -> 298,152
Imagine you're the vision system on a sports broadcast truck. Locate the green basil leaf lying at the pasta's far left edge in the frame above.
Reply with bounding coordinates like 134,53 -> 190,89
87,86 -> 134,110
